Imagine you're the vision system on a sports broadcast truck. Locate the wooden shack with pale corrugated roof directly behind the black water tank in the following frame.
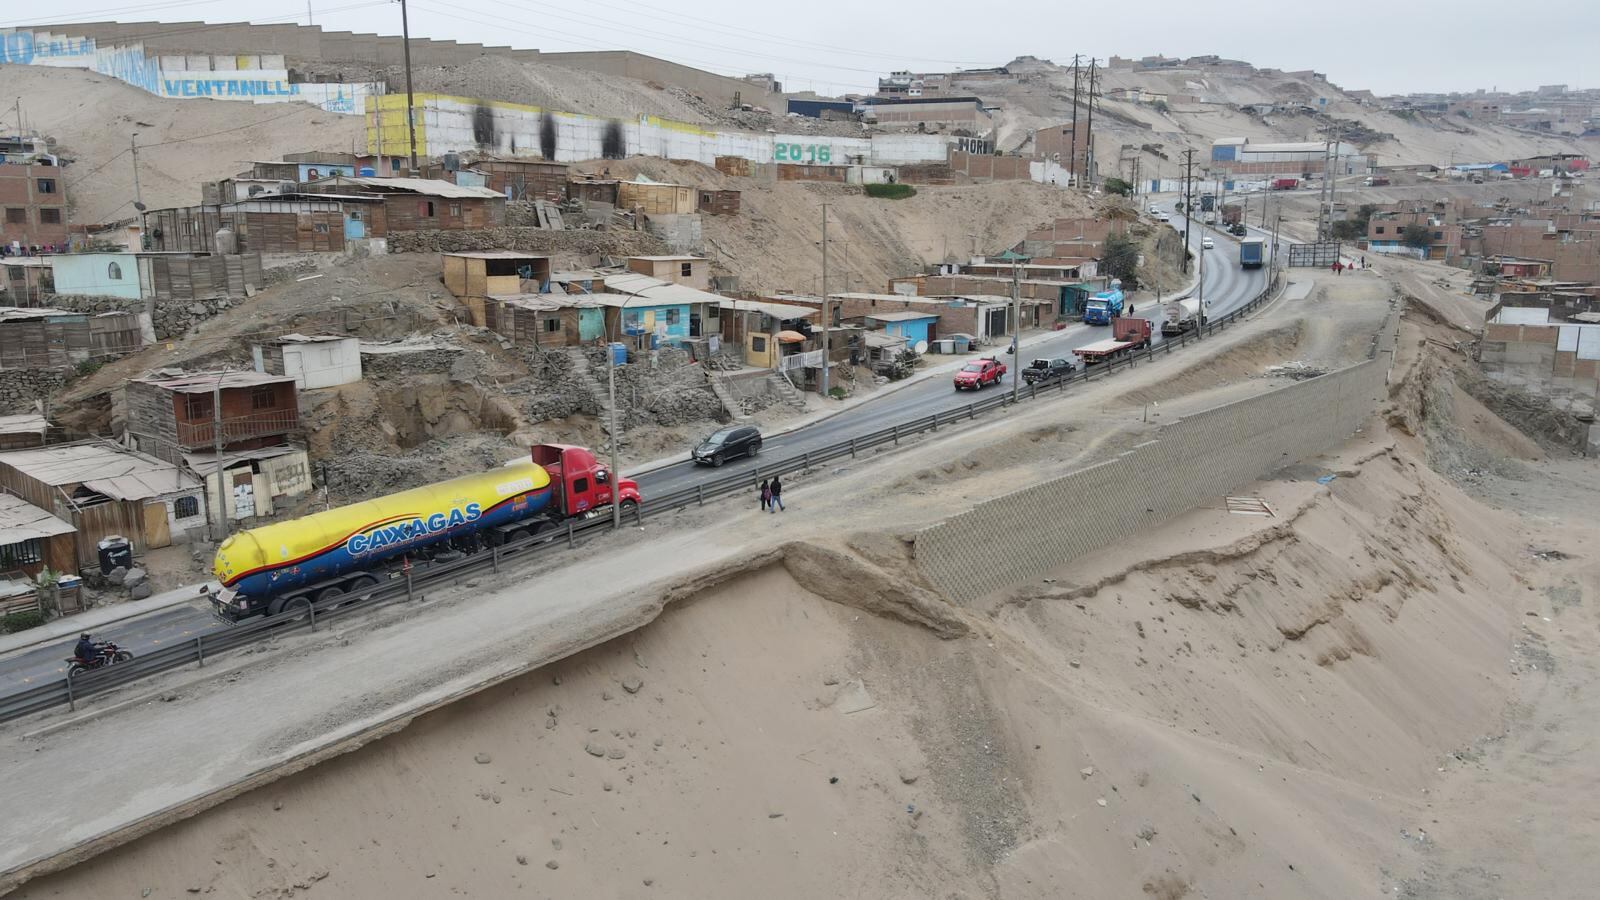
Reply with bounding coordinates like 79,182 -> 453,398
0,440 -> 205,572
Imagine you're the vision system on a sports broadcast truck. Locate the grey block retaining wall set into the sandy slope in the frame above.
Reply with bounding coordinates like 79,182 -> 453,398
915,310 -> 1395,602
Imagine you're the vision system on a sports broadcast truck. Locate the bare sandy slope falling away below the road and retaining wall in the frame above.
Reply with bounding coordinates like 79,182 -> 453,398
21,264 -> 1597,898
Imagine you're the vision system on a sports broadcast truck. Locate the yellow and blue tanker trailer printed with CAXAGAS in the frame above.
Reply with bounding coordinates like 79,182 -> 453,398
211,461 -> 552,621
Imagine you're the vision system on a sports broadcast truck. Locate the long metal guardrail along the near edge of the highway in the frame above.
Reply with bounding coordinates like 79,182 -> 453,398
0,272 -> 1277,722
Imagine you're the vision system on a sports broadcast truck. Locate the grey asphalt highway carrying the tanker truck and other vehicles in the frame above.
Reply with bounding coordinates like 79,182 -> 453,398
0,211 -> 1266,697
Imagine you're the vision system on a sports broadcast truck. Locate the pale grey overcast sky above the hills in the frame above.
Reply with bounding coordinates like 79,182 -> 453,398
0,0 -> 1600,93
